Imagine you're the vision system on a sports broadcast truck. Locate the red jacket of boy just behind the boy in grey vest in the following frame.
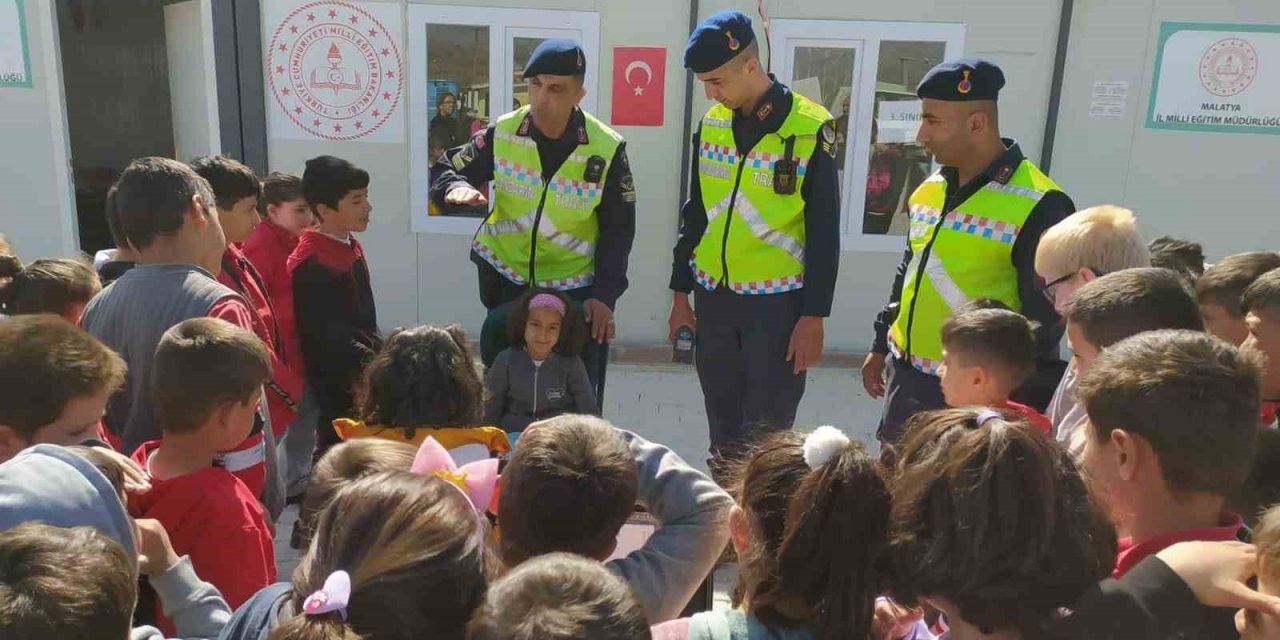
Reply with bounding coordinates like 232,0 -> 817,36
218,243 -> 302,436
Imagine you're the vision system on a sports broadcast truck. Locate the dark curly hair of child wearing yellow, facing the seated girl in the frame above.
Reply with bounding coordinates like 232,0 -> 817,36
356,325 -> 484,439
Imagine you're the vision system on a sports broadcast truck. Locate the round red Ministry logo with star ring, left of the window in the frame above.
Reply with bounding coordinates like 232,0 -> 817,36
266,1 -> 404,141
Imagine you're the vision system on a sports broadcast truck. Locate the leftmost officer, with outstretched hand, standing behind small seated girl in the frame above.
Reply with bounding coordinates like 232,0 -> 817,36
430,40 -> 636,383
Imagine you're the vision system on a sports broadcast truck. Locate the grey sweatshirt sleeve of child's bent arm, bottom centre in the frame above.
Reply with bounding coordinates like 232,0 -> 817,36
607,431 -> 733,625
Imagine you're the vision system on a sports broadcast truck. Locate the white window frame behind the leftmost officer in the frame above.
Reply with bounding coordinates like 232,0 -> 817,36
406,4 -> 602,236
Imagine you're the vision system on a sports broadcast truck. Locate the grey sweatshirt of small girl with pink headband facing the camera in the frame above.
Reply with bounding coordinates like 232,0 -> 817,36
484,348 -> 599,433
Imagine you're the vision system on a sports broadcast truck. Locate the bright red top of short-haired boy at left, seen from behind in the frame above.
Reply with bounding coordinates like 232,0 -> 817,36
129,440 -> 275,637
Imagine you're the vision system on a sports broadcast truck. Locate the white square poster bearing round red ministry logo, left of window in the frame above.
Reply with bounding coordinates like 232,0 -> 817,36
262,0 -> 404,142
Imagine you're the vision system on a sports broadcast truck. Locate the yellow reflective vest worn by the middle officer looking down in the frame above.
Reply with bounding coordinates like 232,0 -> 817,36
690,92 -> 831,294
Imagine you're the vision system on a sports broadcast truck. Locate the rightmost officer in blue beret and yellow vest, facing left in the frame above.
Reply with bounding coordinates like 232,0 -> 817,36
863,60 -> 1075,443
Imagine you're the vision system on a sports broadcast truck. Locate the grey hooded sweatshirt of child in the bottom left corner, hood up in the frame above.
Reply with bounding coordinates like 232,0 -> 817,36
0,444 -> 232,640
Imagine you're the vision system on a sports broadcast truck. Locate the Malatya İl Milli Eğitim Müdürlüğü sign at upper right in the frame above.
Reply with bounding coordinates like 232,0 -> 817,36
1147,22 -> 1280,134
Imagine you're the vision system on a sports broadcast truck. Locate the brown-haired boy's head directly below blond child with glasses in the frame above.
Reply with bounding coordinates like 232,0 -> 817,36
1055,268 -> 1204,454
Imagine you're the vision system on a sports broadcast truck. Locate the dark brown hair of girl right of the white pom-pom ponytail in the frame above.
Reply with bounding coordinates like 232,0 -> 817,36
891,408 -> 1116,634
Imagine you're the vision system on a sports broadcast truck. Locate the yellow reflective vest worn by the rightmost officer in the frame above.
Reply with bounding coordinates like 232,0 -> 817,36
890,160 -> 1057,375
